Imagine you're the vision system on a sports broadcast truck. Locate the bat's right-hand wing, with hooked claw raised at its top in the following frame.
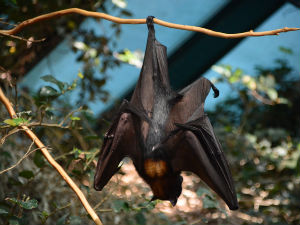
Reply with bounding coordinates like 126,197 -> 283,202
168,78 -> 238,210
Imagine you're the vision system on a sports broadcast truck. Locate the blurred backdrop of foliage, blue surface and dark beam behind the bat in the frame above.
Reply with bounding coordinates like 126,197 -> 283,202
0,0 -> 300,225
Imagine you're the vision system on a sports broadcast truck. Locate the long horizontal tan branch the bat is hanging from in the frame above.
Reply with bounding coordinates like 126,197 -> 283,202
0,8 -> 300,38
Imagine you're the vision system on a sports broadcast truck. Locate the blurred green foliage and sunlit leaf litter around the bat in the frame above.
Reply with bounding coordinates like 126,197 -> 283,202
0,0 -> 300,225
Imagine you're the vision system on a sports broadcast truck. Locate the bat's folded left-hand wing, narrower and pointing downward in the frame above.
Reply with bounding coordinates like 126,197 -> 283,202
94,101 -> 141,191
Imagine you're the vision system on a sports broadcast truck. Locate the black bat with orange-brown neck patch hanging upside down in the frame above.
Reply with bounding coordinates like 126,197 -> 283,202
94,17 -> 238,210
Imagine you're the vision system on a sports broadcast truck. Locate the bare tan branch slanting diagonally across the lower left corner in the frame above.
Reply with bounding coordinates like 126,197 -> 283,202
0,88 -> 102,225
